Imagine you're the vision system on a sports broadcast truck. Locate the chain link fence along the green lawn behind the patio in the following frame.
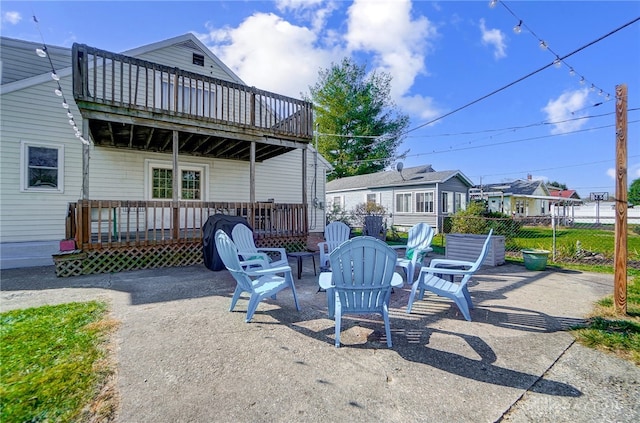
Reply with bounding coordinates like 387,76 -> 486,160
432,216 -> 640,269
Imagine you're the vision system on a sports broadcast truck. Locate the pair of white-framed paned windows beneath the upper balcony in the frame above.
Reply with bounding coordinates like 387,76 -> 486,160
147,161 -> 208,200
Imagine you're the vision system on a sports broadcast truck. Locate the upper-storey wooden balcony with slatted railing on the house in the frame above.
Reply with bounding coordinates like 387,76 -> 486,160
72,44 -> 313,161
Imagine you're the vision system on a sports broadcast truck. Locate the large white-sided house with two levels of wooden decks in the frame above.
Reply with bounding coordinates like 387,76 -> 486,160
0,34 -> 330,271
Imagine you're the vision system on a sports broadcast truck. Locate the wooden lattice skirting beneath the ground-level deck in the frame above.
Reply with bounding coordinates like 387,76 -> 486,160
53,237 -> 306,277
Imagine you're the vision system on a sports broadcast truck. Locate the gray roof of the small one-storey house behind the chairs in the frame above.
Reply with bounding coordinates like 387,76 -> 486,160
326,165 -> 473,192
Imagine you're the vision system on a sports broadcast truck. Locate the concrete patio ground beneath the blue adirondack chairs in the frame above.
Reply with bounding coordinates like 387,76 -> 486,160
0,260 -> 640,423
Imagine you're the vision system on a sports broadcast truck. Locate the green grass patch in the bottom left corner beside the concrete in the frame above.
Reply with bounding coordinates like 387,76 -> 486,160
0,301 -> 117,422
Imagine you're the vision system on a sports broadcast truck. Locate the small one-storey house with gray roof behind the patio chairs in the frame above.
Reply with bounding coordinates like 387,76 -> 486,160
327,165 -> 473,231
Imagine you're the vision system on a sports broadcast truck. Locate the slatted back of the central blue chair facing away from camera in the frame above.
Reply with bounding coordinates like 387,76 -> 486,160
329,236 -> 397,313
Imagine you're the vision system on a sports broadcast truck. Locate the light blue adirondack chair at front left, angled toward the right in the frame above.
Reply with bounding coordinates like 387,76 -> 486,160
215,229 -> 300,323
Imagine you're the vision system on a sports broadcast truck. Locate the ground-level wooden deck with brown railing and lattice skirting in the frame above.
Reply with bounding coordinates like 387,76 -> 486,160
54,200 -> 309,276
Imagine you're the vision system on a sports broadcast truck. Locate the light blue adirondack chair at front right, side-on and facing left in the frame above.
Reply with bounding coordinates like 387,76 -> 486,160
407,229 -> 493,321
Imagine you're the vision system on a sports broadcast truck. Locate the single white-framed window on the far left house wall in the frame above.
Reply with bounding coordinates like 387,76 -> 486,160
20,142 -> 64,192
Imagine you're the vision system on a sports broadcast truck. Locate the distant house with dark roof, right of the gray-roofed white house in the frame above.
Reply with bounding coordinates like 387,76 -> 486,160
469,179 -> 557,217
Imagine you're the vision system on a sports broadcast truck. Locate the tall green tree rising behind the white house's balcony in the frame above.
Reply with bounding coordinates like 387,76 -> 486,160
307,58 -> 409,180
